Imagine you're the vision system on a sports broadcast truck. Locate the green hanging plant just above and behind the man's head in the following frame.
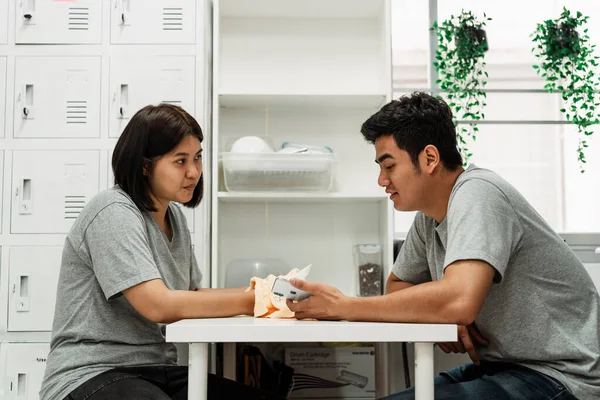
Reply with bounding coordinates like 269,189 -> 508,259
431,10 -> 492,165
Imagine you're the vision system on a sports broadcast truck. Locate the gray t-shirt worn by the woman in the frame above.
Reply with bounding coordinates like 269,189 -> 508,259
40,187 -> 201,400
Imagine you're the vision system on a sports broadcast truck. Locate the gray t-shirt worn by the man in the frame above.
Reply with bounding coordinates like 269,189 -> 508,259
392,165 -> 600,399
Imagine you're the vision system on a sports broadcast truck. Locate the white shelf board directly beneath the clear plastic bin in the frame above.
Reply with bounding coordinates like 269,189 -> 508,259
218,192 -> 387,203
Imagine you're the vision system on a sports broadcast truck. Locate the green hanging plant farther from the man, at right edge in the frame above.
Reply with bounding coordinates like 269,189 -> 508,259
531,8 -> 600,173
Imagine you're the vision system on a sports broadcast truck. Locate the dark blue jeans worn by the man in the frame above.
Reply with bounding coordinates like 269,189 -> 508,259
385,361 -> 577,400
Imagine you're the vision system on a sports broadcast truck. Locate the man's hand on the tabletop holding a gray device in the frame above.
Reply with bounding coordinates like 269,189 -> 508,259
287,279 -> 348,320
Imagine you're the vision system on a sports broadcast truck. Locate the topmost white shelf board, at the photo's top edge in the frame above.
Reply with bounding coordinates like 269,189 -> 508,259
219,0 -> 385,19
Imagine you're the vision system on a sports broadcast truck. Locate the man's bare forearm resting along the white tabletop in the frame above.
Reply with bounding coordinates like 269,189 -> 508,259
343,281 -> 472,325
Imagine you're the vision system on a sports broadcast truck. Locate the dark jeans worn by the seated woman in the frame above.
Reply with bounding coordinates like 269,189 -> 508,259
65,366 -> 282,400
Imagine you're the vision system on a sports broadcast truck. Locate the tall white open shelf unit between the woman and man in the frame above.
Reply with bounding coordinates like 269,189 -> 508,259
211,0 -> 393,396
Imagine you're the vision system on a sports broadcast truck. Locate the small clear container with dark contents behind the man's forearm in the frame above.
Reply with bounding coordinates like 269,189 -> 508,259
353,244 -> 383,297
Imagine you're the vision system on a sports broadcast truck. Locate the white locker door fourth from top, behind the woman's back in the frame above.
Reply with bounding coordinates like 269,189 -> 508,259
8,246 -> 62,332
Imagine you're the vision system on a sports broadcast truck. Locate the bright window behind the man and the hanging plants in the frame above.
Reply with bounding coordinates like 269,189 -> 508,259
392,0 -> 600,235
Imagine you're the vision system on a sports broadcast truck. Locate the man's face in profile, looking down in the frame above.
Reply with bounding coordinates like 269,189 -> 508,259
375,135 -> 426,211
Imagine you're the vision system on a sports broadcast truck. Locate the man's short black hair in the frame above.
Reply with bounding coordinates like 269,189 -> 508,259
361,92 -> 462,171
